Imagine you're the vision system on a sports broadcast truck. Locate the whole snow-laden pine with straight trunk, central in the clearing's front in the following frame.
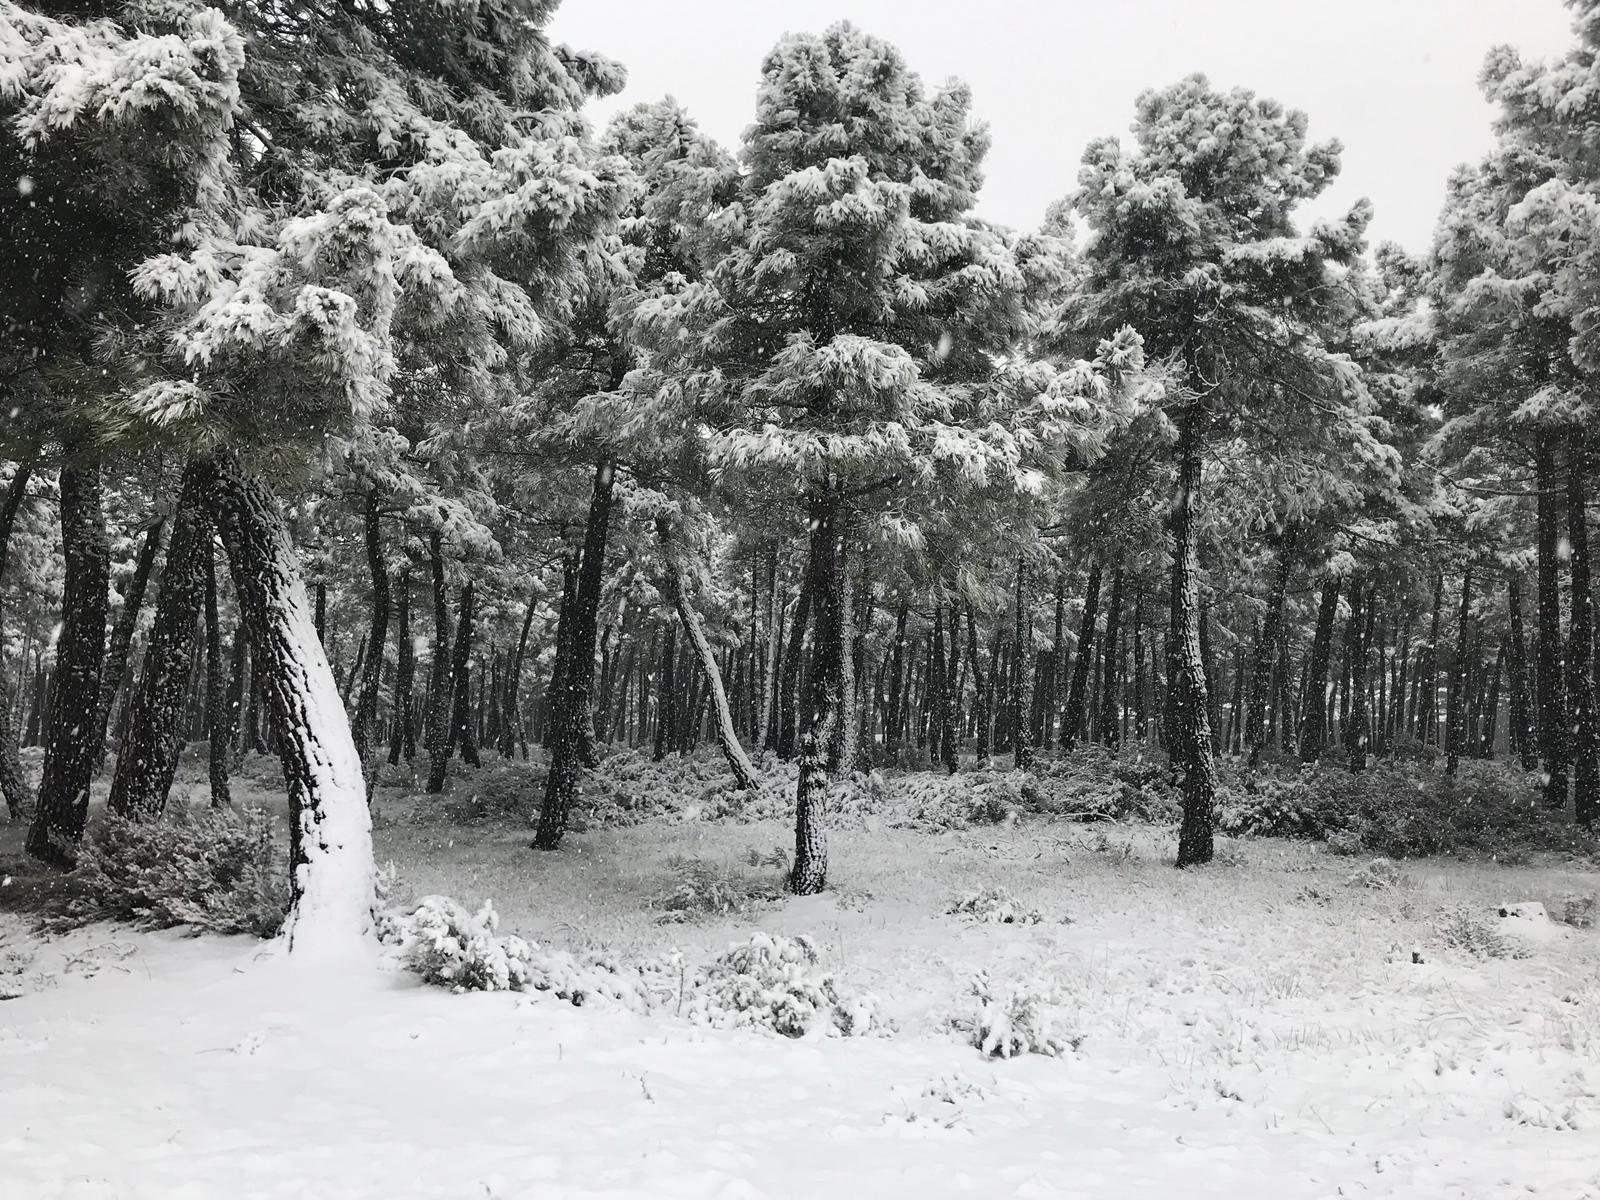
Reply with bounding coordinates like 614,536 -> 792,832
640,24 -> 1142,894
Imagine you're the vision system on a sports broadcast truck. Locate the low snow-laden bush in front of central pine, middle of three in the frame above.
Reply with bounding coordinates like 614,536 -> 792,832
686,933 -> 891,1037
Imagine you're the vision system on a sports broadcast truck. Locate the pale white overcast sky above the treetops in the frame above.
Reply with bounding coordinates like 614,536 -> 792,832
550,0 -> 1570,250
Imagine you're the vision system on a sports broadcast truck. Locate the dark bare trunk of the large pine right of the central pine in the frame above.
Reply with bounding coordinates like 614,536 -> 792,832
1168,411 -> 1216,867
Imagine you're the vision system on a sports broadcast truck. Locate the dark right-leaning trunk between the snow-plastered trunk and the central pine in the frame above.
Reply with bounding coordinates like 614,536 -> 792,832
533,458 -> 616,850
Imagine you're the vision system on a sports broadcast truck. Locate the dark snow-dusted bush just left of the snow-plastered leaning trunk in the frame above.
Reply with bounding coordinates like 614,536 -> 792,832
67,808 -> 290,938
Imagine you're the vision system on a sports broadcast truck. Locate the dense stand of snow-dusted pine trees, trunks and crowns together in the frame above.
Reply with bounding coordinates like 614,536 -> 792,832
0,0 -> 1600,944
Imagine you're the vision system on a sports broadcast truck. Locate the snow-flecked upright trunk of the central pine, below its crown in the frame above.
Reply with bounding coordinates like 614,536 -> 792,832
789,493 -> 848,896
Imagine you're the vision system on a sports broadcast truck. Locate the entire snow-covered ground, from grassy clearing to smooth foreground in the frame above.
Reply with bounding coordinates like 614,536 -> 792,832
0,755 -> 1600,1200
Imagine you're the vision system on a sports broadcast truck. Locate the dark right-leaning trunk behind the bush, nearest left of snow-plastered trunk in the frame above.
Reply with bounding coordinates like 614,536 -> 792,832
109,462 -> 211,821
